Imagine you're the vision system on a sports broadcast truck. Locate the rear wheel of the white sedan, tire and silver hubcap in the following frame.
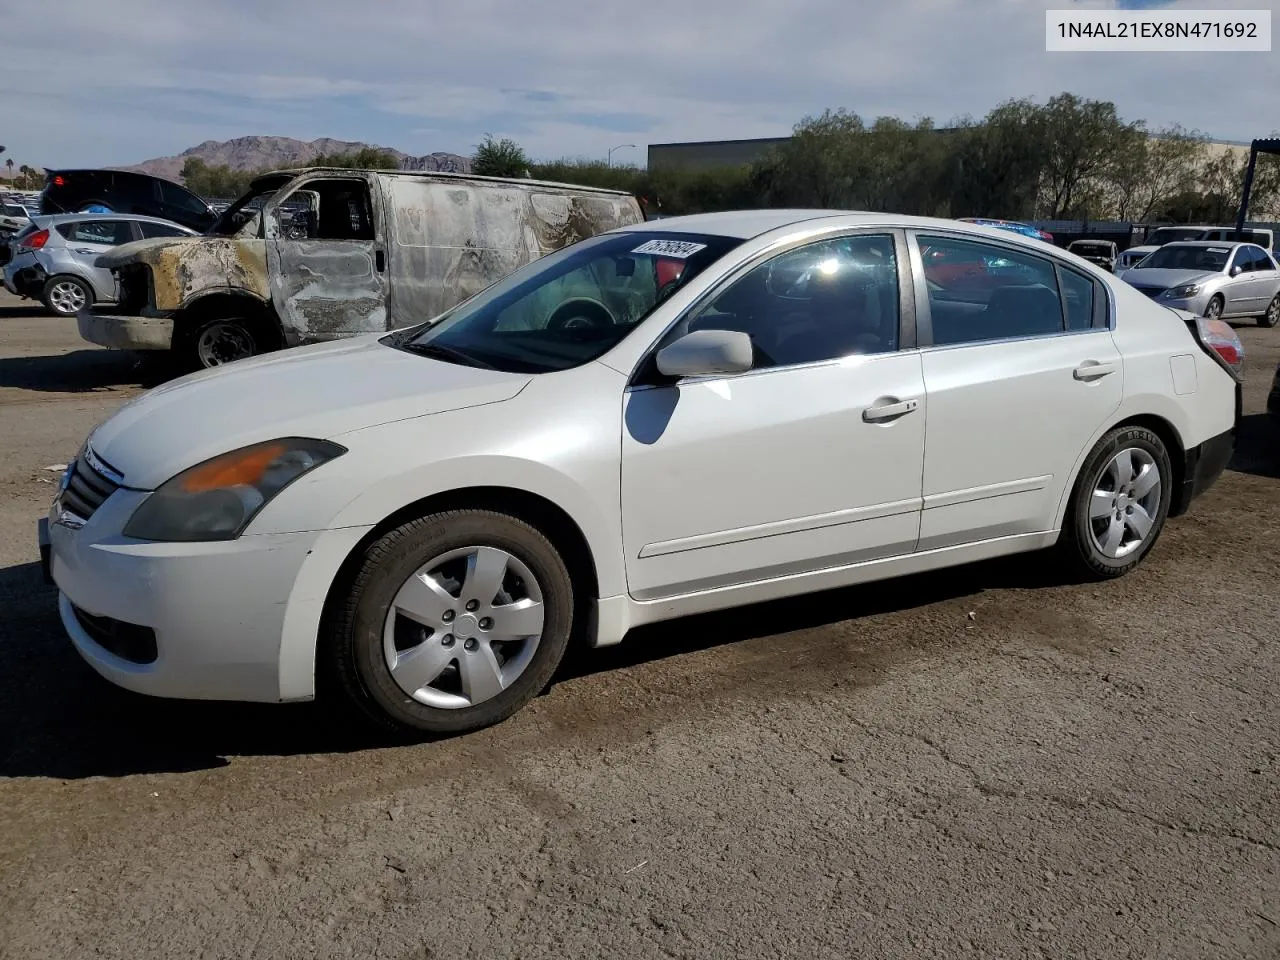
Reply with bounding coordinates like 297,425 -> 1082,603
1061,426 -> 1172,580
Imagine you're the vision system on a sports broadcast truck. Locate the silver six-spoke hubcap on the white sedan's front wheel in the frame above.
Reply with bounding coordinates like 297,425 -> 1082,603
383,547 -> 544,710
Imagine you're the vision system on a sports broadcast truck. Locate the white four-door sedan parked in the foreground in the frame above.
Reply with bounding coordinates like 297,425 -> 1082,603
41,210 -> 1242,733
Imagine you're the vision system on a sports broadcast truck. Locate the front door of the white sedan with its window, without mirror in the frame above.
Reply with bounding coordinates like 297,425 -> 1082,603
622,233 -> 925,599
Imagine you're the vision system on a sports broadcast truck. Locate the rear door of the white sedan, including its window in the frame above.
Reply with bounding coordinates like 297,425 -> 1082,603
919,229 -> 1124,550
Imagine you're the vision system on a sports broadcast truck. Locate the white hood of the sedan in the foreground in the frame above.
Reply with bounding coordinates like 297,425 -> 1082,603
90,334 -> 531,490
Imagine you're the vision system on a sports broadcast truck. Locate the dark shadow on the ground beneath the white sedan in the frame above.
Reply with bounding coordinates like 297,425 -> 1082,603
0,558 -> 1064,780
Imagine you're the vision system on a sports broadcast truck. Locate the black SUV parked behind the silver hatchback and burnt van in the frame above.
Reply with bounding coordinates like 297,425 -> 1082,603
40,170 -> 218,233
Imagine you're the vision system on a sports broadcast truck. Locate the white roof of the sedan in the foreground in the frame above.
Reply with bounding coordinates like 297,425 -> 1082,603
614,209 -> 1056,250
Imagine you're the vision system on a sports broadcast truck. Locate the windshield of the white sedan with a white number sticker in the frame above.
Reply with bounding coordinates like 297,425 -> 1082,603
388,230 -> 742,374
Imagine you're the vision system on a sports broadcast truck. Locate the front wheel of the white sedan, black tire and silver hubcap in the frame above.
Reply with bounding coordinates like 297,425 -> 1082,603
324,509 -> 573,735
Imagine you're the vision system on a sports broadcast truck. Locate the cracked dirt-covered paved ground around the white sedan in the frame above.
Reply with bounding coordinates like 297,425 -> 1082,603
0,294 -> 1280,960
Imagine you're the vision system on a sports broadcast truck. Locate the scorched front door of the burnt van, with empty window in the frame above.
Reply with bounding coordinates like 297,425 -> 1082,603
265,178 -> 388,344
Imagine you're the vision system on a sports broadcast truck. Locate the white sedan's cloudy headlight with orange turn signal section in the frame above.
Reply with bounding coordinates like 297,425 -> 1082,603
124,436 -> 347,543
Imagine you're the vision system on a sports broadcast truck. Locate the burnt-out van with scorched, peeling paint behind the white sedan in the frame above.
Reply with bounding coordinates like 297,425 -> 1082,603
79,169 -> 644,369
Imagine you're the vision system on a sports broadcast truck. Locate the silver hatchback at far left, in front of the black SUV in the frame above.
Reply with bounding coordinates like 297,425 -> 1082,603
4,214 -> 197,316
